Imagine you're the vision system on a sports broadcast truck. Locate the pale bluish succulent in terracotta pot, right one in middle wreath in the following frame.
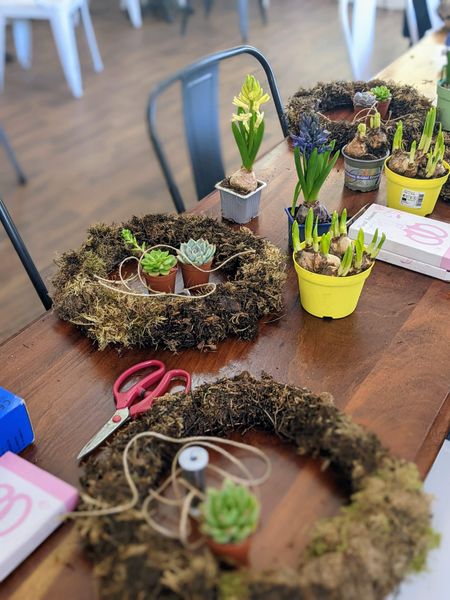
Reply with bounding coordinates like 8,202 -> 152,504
177,238 -> 216,288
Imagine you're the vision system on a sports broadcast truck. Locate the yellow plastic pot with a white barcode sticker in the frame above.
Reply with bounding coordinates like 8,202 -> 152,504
384,158 -> 450,216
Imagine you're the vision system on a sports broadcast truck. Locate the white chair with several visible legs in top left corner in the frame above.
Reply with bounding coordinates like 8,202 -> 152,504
0,0 -> 103,98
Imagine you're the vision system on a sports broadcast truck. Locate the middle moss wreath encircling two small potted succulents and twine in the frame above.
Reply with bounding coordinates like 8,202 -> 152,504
53,215 -> 286,351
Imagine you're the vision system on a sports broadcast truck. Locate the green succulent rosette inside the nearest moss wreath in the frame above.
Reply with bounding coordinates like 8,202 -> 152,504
200,480 -> 261,544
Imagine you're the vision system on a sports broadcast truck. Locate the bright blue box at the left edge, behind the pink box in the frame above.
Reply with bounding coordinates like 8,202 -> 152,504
0,387 -> 34,456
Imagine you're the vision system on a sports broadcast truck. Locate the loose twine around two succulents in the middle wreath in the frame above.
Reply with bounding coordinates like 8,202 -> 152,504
94,244 -> 255,300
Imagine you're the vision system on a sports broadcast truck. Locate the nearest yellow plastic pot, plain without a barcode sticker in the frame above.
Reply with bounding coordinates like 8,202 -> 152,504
292,244 -> 373,319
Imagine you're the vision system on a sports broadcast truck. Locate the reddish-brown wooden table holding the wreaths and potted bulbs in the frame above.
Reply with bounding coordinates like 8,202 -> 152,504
0,38 -> 450,600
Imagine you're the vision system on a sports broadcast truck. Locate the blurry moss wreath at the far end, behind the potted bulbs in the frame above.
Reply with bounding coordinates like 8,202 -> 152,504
286,79 -> 450,202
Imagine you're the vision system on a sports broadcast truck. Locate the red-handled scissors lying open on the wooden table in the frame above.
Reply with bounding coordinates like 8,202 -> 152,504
77,360 -> 191,460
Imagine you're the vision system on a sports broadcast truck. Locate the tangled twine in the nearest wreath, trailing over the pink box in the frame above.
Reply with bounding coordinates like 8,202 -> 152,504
66,431 -> 272,549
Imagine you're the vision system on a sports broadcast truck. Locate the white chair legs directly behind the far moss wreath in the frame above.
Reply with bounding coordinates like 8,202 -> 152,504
339,0 -> 377,80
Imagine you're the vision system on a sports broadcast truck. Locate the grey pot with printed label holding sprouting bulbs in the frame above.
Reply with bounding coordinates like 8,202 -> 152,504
342,111 -> 389,192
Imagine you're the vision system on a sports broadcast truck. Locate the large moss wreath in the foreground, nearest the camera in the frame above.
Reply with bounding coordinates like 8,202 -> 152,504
80,373 -> 437,600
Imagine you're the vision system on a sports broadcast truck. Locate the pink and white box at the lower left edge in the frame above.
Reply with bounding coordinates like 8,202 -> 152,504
0,452 -> 78,581
